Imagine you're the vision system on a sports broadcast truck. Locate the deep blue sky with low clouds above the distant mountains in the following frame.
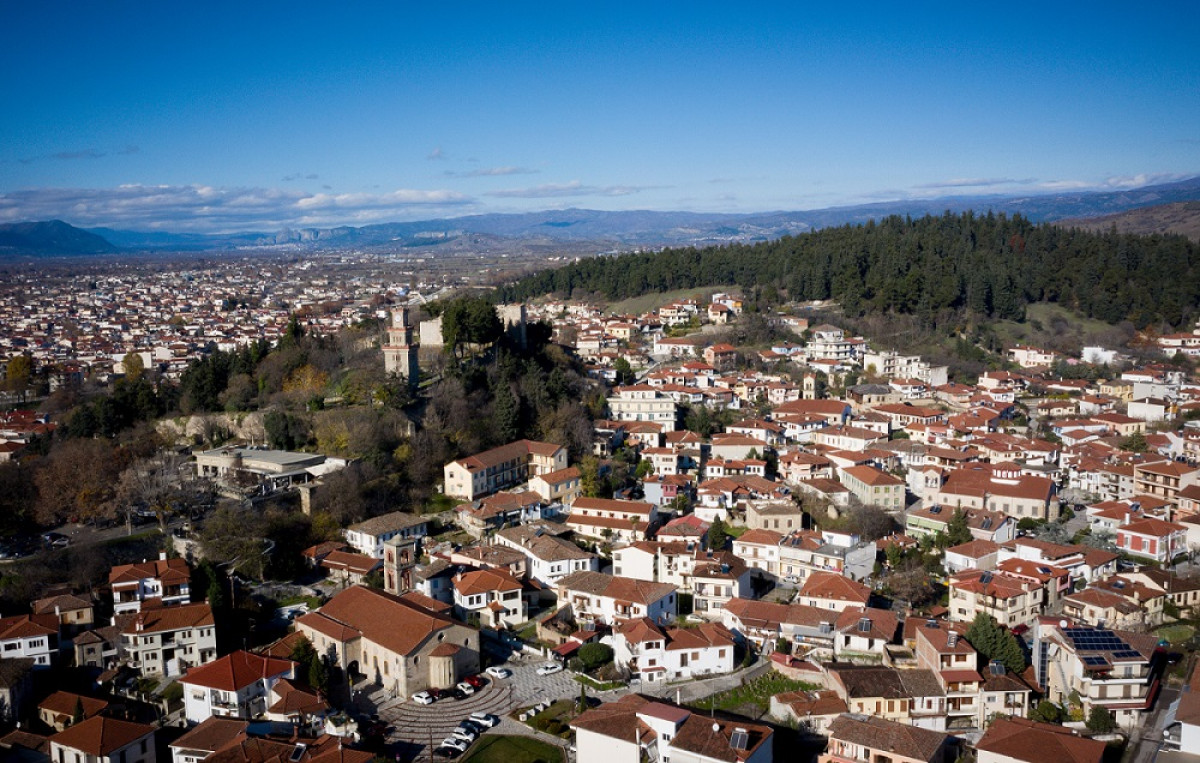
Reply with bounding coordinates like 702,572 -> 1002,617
0,0 -> 1200,232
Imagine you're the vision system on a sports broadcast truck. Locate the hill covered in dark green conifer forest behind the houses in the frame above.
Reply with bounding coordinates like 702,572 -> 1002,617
500,212 -> 1200,326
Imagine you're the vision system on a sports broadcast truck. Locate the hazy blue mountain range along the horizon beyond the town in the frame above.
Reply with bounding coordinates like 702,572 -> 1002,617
7,178 -> 1200,256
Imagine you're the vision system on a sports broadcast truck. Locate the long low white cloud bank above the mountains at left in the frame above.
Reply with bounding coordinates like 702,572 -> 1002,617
0,185 -> 474,232
